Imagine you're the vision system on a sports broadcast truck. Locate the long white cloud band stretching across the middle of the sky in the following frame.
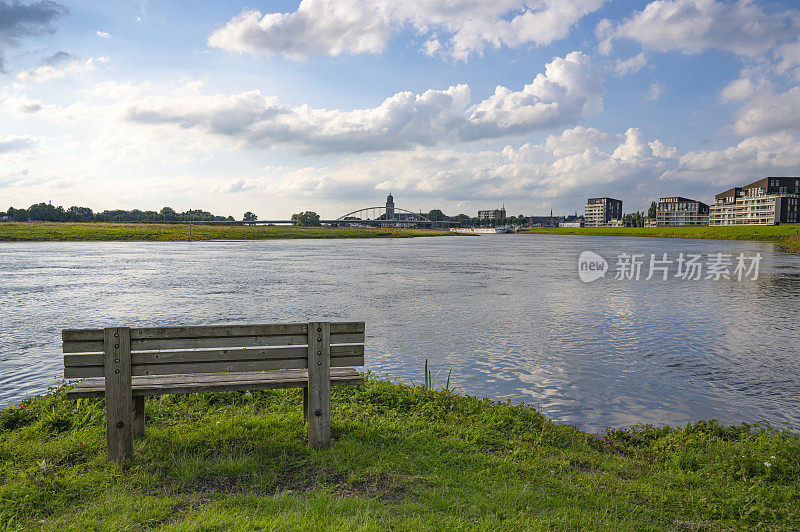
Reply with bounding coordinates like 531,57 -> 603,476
125,52 -> 602,153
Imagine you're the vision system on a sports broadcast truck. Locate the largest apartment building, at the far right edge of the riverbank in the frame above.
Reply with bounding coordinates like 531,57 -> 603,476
708,177 -> 800,225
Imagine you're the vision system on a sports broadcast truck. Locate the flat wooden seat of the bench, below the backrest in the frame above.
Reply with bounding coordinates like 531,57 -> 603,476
67,368 -> 364,399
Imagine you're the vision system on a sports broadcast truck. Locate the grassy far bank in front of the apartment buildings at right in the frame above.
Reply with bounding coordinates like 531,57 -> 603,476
522,224 -> 800,251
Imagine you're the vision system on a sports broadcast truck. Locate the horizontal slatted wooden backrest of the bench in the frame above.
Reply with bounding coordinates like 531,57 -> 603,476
62,322 -> 364,379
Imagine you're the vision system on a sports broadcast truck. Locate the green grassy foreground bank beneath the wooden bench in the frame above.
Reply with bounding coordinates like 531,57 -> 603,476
0,379 -> 800,531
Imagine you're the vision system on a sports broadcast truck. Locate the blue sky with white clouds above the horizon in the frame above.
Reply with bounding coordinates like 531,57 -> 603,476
0,0 -> 800,219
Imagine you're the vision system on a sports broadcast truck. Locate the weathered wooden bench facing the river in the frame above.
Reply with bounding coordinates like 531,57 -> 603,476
62,322 -> 364,460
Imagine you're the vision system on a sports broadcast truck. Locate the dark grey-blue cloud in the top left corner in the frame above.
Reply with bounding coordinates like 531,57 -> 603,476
0,0 -> 69,71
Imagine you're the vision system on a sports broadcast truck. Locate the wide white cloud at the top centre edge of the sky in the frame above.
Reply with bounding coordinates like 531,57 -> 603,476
208,0 -> 606,60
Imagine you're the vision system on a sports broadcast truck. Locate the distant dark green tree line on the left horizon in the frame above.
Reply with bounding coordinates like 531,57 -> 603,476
6,203 -> 238,222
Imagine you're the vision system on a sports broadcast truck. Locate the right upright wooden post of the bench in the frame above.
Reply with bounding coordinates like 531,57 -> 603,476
308,322 -> 331,449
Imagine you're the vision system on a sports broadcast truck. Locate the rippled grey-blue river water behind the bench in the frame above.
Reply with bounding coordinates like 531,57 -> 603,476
0,235 -> 800,431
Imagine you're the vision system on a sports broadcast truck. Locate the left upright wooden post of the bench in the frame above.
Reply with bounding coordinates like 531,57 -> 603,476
103,327 -> 133,460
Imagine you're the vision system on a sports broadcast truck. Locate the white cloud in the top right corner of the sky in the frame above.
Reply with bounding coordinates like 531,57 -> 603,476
597,0 -> 800,57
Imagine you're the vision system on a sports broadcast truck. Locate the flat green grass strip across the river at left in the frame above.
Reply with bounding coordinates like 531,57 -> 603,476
0,222 -> 453,242
